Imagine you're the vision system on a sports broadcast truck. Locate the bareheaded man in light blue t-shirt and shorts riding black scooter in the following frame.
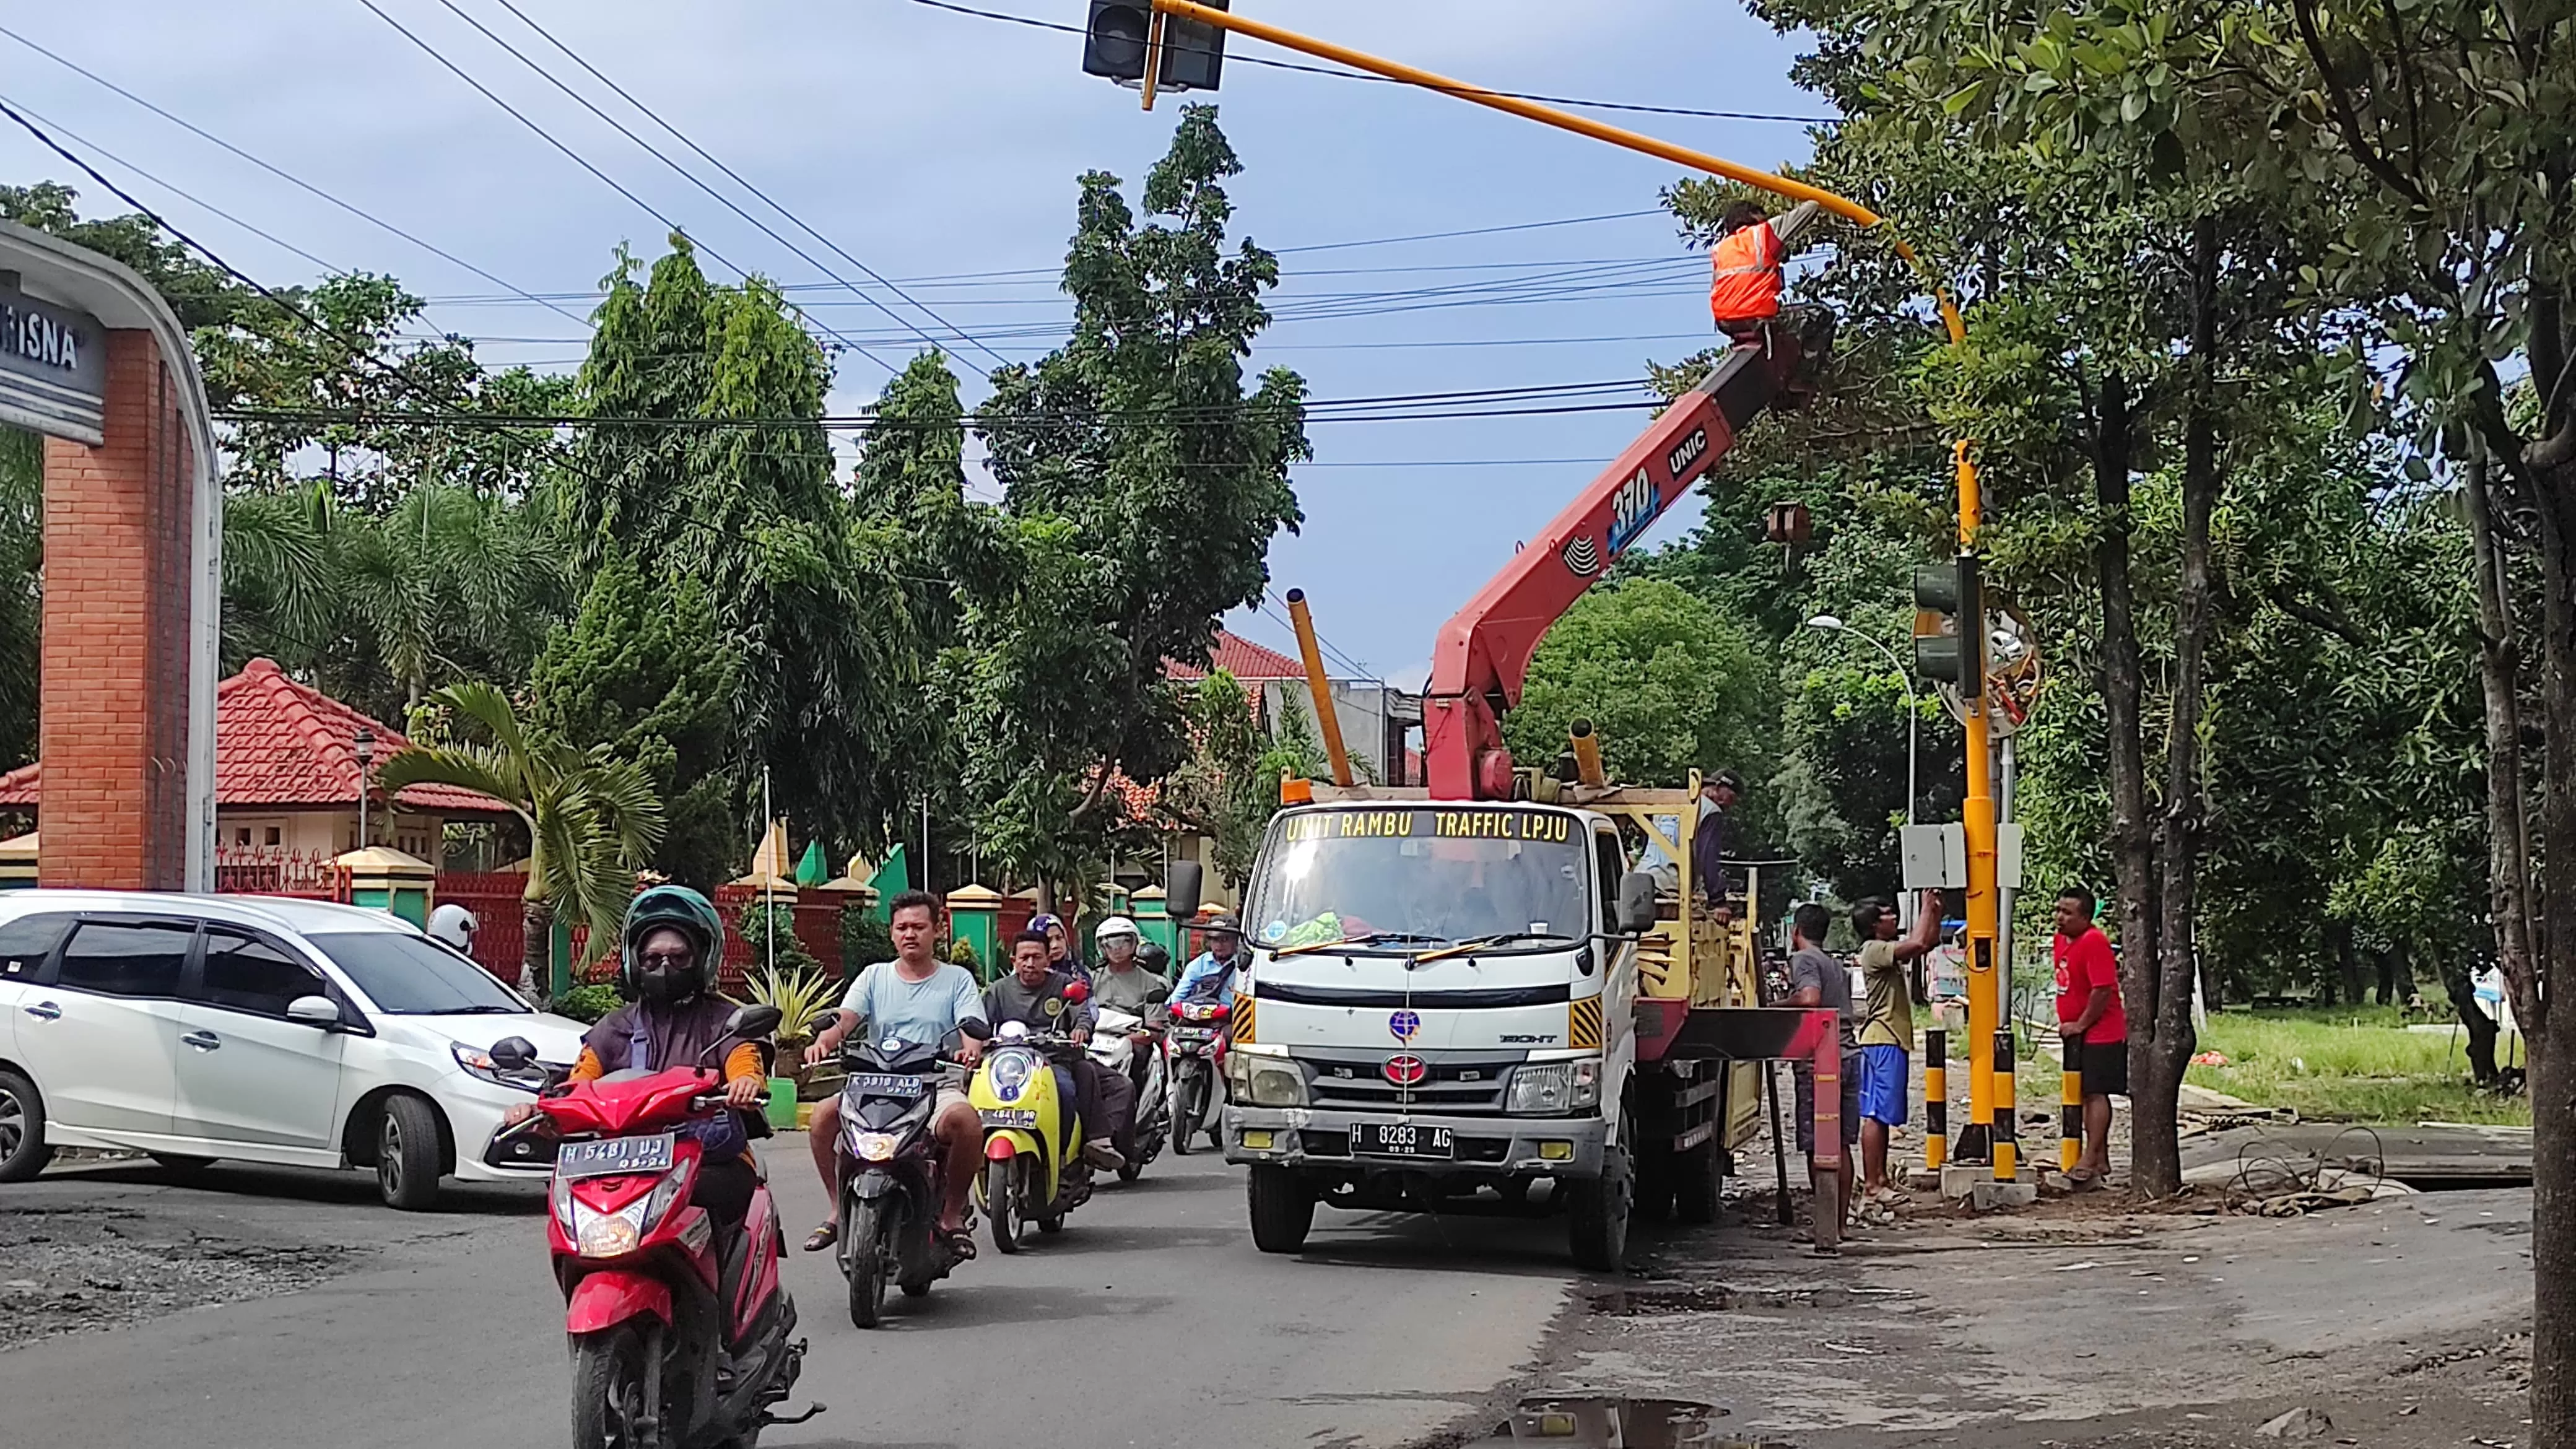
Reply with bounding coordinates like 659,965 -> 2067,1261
806,889 -> 984,1258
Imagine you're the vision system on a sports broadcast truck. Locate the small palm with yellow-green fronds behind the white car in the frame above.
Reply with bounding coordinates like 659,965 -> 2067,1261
376,681 -> 662,993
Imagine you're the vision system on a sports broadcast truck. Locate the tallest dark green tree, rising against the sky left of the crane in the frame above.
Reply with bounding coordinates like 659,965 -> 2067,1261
943,106 -> 1308,889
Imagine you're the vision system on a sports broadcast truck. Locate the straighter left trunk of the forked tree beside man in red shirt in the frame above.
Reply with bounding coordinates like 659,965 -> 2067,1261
2092,374 -> 2156,1134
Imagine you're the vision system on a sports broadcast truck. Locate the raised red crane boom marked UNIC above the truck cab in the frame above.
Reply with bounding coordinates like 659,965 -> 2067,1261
1422,328 -> 1801,799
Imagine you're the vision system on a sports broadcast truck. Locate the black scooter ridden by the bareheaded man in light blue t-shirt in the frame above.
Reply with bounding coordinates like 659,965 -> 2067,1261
835,1020 -> 955,1328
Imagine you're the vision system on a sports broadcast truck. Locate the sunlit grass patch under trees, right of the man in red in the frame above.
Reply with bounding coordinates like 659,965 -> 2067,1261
2185,1006 -> 2532,1127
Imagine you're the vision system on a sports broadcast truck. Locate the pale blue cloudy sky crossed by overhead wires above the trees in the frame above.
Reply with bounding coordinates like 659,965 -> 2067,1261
0,0 -> 1821,686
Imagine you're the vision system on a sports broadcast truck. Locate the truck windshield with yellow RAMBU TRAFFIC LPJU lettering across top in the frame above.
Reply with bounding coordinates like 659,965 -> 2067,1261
1244,807 -> 1592,951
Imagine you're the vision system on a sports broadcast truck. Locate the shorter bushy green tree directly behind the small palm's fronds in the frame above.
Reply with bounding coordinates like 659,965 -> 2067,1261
528,554 -> 744,889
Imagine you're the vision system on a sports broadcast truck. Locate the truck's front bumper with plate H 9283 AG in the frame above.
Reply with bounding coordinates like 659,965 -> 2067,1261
1226,1103 -> 1610,1178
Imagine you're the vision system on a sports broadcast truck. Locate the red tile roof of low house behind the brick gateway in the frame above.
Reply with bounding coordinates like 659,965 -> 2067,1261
0,660 -> 510,815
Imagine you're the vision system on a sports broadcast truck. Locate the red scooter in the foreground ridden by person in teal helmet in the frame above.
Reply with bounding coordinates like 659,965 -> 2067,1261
492,1006 -> 822,1449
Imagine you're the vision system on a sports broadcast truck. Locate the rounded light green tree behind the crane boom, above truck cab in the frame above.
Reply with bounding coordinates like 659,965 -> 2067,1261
1504,578 -> 1780,786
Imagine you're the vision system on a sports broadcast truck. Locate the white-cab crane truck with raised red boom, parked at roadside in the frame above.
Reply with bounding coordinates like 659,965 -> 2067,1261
1167,330 -> 1839,1271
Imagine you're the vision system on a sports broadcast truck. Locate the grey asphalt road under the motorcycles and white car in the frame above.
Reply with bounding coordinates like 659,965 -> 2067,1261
0,1137 -> 1574,1449
